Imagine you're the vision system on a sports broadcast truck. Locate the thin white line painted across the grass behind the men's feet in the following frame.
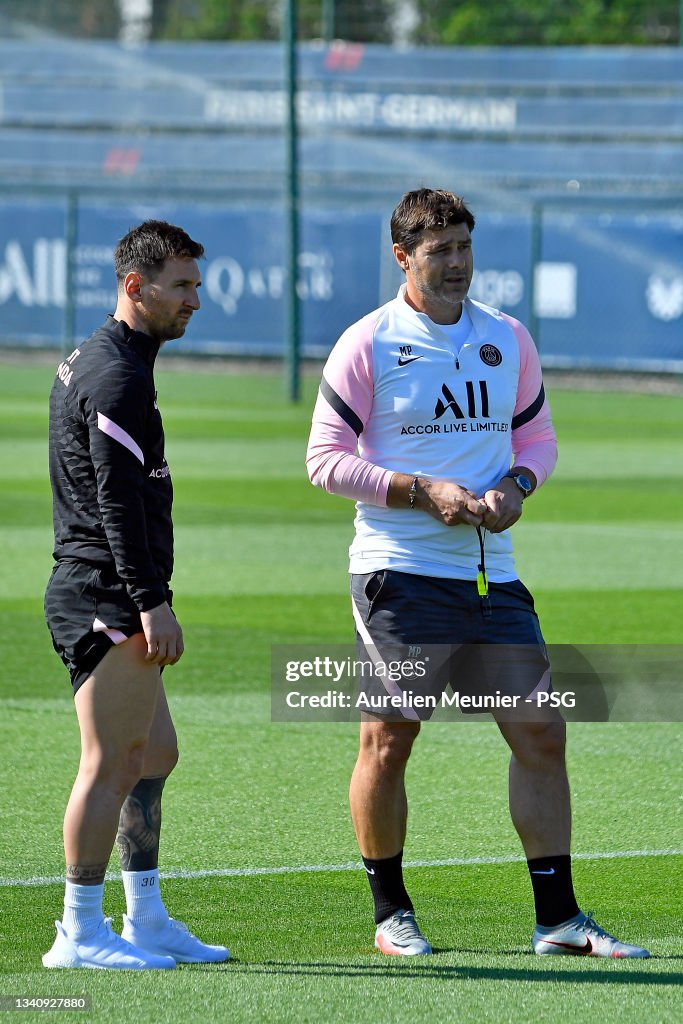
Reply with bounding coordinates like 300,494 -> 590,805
0,850 -> 683,889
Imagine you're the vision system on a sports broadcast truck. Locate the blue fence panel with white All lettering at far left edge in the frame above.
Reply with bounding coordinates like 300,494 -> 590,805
0,201 -> 67,345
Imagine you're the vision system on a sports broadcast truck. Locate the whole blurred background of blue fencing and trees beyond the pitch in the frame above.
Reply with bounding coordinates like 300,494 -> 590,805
0,0 -> 683,372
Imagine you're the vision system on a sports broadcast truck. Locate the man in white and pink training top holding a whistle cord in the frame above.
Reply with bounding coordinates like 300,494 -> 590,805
307,188 -> 649,957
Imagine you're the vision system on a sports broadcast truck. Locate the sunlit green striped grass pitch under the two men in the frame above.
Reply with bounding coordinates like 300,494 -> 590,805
0,360 -> 683,1024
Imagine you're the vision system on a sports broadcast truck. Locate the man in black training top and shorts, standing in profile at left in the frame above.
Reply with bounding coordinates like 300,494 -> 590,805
43,220 -> 229,970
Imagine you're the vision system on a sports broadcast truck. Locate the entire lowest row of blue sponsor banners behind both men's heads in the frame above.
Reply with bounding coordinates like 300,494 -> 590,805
0,199 -> 683,372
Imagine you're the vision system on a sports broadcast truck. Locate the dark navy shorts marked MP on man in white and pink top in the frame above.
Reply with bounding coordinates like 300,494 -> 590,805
351,569 -> 550,721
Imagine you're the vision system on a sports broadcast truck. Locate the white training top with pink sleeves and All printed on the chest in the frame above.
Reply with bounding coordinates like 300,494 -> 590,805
306,285 -> 557,583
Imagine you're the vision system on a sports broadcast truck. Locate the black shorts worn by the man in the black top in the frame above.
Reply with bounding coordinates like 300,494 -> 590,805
45,561 -> 172,693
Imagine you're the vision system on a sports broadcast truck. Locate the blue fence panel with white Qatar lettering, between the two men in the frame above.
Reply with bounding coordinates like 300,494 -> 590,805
76,204 -> 381,355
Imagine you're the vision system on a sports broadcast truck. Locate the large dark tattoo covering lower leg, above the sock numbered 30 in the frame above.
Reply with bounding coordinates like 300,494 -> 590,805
116,777 -> 166,871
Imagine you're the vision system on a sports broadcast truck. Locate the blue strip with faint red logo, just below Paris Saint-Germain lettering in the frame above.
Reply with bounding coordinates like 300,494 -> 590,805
0,128 -> 683,189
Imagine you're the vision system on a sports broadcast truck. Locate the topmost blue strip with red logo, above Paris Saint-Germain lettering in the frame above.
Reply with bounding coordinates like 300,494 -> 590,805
0,39 -> 683,89
